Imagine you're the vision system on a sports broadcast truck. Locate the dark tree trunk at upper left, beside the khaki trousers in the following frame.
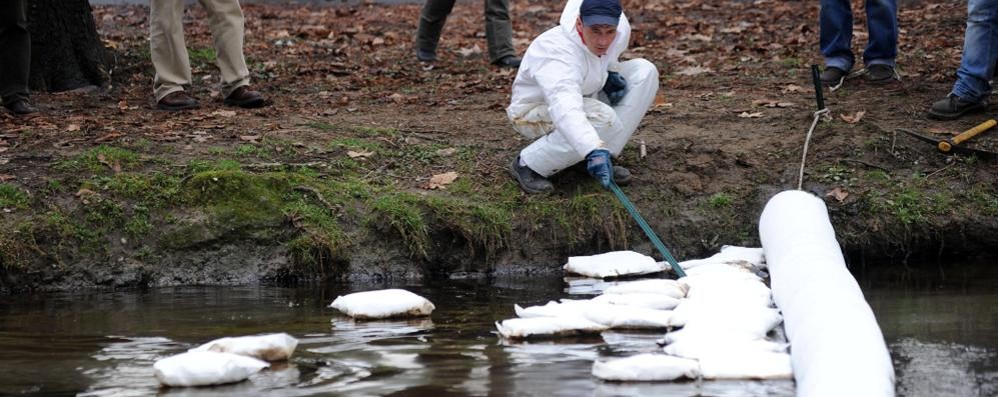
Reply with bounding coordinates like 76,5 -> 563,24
27,0 -> 107,91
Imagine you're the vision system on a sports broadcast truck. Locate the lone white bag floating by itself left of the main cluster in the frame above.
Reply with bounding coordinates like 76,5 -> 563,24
329,289 -> 436,320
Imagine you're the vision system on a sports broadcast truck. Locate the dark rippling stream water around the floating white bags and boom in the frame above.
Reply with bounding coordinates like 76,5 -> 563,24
0,278 -> 998,396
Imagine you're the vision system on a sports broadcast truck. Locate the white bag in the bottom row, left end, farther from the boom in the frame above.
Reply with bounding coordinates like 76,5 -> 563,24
592,353 -> 700,382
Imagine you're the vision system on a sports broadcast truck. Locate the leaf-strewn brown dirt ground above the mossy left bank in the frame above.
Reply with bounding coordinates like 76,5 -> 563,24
0,0 -> 998,290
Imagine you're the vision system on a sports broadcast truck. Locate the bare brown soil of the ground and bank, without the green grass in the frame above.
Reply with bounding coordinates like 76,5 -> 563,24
0,0 -> 998,291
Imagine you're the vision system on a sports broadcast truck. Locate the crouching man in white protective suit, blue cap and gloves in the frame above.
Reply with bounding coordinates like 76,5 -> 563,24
506,0 -> 658,193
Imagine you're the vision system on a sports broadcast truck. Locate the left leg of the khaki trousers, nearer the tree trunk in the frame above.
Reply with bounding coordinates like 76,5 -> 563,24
149,0 -> 191,101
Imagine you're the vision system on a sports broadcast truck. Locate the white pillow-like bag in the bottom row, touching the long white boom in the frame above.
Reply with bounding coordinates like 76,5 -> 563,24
699,350 -> 792,378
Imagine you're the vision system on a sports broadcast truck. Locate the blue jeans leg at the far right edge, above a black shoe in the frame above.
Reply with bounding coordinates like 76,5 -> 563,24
953,0 -> 998,102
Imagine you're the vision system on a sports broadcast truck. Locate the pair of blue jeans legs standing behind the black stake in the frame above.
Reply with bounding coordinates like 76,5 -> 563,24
819,0 -> 898,71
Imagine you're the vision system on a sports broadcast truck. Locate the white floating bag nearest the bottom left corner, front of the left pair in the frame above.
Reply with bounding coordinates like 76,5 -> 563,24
153,351 -> 270,386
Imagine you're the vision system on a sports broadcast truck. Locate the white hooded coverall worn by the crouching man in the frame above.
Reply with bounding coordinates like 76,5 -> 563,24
506,0 -> 658,177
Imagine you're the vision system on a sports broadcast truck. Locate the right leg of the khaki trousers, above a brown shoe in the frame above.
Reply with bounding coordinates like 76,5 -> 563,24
200,0 -> 250,98
